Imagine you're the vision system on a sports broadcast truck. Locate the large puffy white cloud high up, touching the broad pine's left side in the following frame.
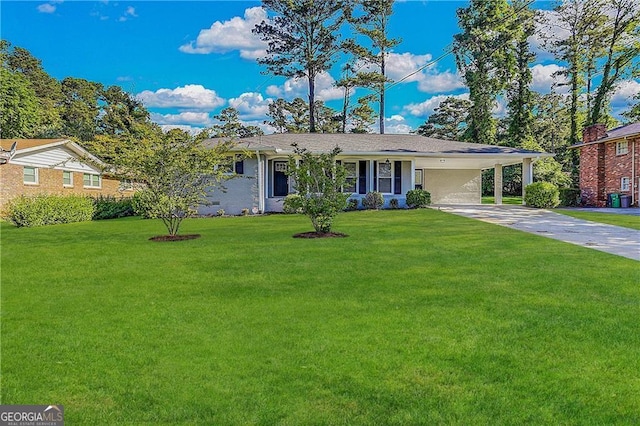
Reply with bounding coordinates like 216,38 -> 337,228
180,7 -> 267,59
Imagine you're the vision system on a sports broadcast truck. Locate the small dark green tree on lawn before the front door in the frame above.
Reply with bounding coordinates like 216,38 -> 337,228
287,144 -> 351,234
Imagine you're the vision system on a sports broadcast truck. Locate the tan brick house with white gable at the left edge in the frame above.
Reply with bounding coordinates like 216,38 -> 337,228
0,139 -> 133,212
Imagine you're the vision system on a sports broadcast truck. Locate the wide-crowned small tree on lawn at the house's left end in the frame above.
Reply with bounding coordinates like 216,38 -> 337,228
103,128 -> 231,237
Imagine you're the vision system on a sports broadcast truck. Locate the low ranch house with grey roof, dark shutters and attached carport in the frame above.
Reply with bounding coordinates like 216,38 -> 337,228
200,133 -> 552,214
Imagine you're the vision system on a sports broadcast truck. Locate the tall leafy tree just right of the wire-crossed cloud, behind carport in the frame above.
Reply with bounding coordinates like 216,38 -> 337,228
453,0 -> 514,144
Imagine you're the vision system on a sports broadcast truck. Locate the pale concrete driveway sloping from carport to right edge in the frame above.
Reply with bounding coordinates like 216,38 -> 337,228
432,205 -> 640,261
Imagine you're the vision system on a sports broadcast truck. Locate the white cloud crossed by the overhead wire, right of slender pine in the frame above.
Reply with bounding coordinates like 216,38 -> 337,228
386,53 -> 464,93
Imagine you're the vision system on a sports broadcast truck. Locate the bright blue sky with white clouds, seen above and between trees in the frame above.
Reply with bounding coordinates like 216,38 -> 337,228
0,0 -> 640,133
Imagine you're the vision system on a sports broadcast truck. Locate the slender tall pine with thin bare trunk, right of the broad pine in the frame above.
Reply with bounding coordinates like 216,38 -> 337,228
344,0 -> 400,134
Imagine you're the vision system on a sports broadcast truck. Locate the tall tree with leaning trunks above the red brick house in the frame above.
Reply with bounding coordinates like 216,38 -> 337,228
589,0 -> 640,124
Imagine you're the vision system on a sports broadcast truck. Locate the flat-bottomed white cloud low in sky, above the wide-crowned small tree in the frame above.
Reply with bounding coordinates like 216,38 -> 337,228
137,84 -> 225,109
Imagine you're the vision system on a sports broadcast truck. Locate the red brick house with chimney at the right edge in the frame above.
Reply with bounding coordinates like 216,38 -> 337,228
572,123 -> 640,207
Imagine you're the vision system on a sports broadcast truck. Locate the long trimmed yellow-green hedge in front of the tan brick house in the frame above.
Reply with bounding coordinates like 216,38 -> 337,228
7,195 -> 95,227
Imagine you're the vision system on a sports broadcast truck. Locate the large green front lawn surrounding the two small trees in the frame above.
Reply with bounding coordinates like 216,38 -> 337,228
1,209 -> 640,425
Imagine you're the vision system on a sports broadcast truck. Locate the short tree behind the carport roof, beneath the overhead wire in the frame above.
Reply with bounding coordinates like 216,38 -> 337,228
416,96 -> 471,141
